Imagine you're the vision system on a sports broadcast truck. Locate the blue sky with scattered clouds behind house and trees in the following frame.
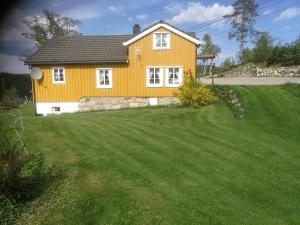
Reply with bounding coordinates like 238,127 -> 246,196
0,0 -> 300,73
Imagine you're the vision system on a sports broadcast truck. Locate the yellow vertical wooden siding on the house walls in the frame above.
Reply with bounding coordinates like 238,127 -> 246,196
34,28 -> 196,102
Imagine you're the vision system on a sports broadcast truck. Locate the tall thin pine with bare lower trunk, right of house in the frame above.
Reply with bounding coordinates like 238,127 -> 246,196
227,0 -> 258,63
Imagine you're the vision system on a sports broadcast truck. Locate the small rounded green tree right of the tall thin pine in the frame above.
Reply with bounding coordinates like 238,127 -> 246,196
253,32 -> 274,63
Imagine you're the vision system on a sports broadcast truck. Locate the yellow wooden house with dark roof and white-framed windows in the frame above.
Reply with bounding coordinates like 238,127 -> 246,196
25,21 -> 200,115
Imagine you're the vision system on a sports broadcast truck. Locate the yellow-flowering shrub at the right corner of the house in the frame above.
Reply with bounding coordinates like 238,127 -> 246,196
177,75 -> 217,108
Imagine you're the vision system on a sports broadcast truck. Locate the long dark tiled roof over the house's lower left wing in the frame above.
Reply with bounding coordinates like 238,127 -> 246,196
25,35 -> 133,65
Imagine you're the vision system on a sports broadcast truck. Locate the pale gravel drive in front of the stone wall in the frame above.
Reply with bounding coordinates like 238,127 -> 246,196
200,77 -> 300,85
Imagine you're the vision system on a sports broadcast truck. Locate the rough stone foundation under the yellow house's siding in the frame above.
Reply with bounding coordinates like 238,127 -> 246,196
79,97 -> 180,112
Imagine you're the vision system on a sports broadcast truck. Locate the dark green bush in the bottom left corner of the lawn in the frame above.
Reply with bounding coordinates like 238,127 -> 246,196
0,134 -> 61,224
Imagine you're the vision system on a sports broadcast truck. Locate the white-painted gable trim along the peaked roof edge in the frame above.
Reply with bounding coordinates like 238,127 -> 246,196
123,23 -> 201,46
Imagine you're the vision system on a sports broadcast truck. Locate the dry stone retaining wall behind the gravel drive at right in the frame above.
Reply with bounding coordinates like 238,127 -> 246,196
223,65 -> 300,77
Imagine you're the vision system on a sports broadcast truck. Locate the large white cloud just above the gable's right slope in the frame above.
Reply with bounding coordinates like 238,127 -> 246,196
168,2 -> 233,24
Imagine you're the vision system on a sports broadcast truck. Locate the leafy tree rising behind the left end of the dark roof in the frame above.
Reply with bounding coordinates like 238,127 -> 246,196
22,10 -> 80,49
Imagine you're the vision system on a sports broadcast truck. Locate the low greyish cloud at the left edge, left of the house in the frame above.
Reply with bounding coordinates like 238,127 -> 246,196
0,53 -> 30,74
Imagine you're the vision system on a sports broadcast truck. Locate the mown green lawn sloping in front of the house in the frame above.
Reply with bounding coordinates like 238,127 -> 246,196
0,86 -> 300,225
